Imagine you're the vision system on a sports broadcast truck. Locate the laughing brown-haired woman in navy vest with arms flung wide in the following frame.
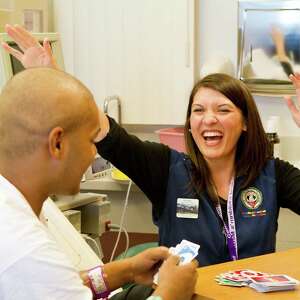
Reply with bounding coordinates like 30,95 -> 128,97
97,74 -> 300,266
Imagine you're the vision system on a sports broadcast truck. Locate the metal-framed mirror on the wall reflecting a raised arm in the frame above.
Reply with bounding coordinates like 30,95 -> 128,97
238,0 -> 300,95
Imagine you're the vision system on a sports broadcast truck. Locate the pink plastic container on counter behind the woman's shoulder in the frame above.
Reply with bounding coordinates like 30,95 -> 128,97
155,127 -> 186,152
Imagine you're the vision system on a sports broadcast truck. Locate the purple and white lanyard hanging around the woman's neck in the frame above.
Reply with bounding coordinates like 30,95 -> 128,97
216,178 -> 238,260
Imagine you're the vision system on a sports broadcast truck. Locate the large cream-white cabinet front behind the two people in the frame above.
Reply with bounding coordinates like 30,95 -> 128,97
55,0 -> 195,124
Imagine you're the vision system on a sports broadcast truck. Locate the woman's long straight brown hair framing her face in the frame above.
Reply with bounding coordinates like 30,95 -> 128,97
184,73 -> 271,203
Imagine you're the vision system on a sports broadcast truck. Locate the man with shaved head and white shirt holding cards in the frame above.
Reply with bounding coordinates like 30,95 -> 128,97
0,68 -> 196,300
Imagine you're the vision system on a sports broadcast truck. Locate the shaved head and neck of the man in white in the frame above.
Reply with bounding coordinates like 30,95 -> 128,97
0,68 -> 100,209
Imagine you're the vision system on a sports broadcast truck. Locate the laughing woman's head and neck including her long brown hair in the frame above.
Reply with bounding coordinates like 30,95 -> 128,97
185,74 -> 271,203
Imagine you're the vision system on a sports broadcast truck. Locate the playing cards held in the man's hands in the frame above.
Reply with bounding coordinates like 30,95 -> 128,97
153,240 -> 200,284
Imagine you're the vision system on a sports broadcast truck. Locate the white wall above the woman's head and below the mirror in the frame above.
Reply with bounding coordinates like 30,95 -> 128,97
196,0 -> 300,145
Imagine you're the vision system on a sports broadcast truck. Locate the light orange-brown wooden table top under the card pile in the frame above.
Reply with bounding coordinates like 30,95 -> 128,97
193,248 -> 300,300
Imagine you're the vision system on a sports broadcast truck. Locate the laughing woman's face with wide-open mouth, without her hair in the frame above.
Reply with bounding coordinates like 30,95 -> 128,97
190,87 -> 246,164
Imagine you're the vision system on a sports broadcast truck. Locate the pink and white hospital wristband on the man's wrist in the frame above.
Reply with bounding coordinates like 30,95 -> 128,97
88,266 -> 110,299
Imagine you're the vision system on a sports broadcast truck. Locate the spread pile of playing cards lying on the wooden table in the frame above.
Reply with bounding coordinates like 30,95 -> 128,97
216,270 -> 299,293
